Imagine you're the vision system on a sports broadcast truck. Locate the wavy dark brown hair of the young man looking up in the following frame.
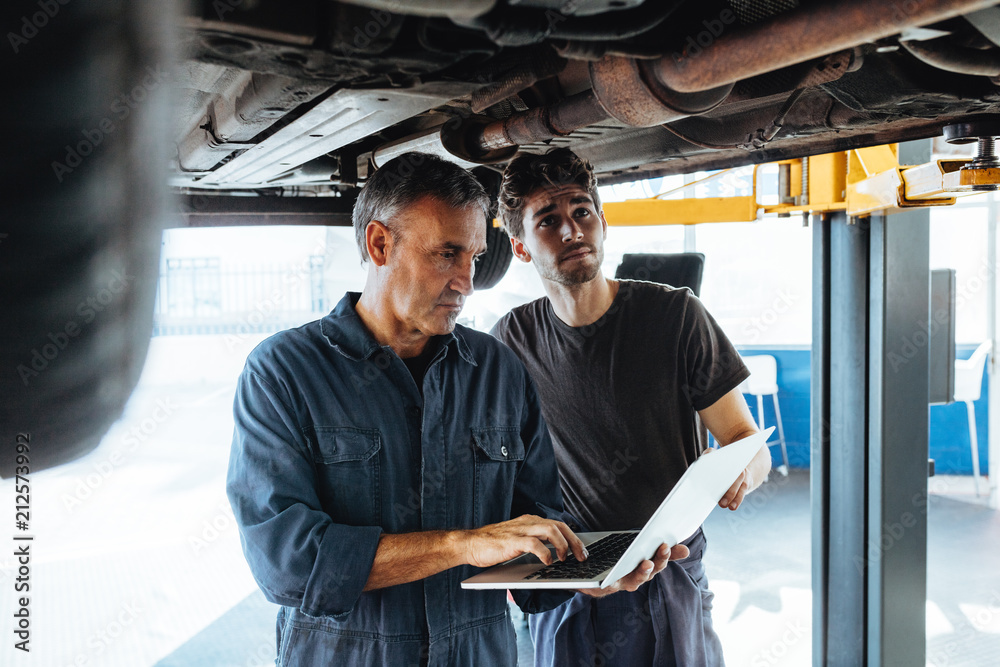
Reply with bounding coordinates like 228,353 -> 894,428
500,148 -> 601,239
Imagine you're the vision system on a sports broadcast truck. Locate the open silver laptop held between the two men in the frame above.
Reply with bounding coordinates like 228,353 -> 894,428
462,426 -> 774,588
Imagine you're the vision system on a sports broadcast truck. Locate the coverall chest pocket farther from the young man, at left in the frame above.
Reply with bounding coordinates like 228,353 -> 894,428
315,427 -> 382,526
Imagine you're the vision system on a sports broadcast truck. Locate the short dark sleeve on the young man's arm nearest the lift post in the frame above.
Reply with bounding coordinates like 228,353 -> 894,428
679,292 -> 750,410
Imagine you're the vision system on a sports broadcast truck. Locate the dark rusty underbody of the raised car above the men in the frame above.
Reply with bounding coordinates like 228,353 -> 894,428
171,0 -> 1000,199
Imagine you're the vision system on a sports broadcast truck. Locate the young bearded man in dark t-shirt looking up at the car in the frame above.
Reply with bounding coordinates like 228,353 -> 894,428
493,148 -> 771,667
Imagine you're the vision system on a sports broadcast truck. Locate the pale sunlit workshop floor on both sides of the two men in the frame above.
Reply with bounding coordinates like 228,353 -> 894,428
0,340 -> 1000,667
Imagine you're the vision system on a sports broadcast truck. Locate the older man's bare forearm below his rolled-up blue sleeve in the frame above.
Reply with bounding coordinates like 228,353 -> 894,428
364,530 -> 465,591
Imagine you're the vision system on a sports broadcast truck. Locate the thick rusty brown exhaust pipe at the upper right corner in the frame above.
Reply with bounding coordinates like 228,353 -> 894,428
655,0 -> 996,93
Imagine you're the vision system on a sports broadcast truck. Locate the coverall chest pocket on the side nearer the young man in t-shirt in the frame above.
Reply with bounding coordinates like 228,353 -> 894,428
472,427 -> 524,526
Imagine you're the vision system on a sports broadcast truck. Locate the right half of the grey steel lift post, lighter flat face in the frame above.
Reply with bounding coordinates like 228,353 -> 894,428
867,209 -> 930,667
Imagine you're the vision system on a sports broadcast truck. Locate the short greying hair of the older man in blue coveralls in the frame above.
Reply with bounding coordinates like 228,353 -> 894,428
352,152 -> 490,262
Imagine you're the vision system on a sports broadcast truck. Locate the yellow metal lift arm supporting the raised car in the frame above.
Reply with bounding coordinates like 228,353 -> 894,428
604,144 -> 1000,226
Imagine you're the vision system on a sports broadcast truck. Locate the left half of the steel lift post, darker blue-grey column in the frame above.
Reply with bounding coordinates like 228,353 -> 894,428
812,213 -> 870,665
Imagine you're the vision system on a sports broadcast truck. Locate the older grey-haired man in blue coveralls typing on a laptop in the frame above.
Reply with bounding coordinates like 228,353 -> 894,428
228,153 -> 677,667
